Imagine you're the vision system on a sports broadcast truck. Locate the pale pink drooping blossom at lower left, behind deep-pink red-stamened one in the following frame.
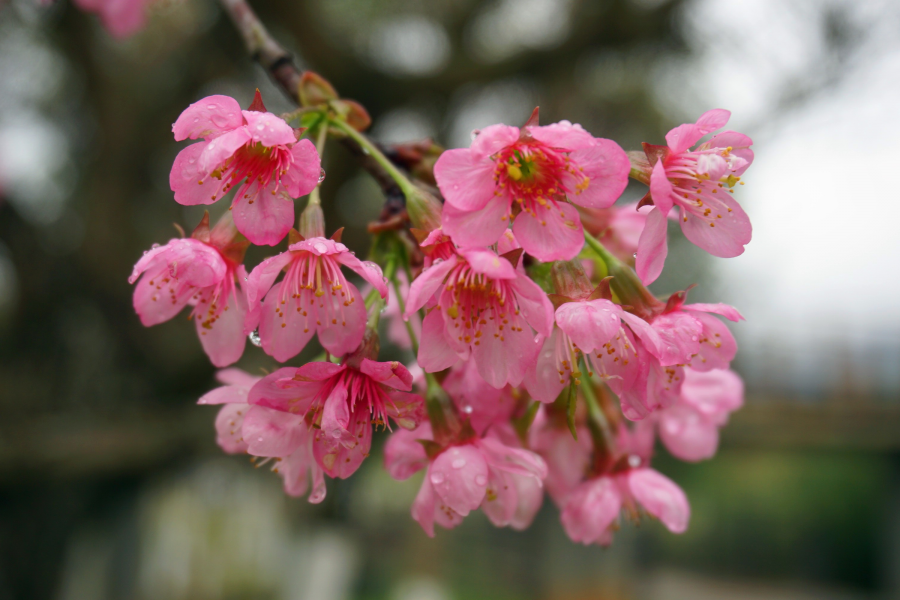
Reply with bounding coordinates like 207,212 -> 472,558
197,369 -> 325,504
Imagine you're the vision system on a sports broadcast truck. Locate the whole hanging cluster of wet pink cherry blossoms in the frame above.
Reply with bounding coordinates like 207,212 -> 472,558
130,82 -> 753,545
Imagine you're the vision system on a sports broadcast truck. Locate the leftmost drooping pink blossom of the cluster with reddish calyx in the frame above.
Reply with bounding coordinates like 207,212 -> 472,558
128,215 -> 248,367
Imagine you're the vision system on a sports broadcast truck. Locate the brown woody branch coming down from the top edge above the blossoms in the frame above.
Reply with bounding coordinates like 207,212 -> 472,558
219,0 -> 405,199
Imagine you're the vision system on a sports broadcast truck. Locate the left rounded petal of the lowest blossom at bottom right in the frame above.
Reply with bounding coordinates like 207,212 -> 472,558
560,477 -> 622,546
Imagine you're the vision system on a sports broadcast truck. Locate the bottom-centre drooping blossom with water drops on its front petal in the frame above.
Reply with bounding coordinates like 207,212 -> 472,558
385,424 -> 547,537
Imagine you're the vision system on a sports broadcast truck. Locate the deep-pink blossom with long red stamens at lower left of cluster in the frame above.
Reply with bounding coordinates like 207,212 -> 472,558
244,355 -> 424,478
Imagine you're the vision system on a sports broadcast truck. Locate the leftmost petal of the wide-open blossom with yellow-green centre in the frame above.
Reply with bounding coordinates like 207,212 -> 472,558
434,148 -> 497,211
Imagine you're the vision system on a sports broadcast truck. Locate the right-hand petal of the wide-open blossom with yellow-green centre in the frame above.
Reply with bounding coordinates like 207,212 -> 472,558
563,138 -> 631,208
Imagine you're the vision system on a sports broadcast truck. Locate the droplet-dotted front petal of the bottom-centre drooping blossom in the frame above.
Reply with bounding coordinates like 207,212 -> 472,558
428,445 -> 488,517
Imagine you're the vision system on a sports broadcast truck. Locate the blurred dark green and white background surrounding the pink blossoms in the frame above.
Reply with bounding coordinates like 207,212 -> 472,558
0,0 -> 900,600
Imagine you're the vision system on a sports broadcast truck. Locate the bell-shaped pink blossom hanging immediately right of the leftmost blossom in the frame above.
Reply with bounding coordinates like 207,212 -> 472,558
247,238 -> 388,362
